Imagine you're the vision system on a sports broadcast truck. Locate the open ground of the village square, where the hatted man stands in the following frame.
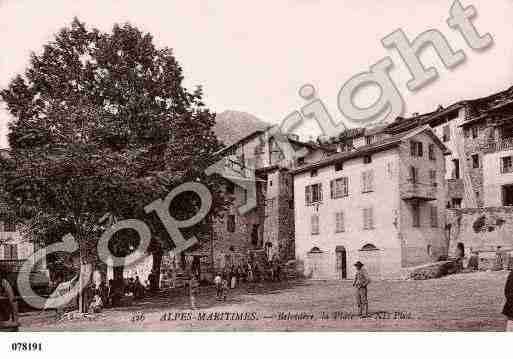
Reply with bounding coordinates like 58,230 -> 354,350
20,271 -> 507,331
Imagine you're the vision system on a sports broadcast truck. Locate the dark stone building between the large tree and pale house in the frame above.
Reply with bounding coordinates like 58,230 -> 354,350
213,129 -> 329,268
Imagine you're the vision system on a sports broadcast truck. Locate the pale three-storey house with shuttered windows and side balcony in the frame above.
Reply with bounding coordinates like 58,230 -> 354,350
292,126 -> 451,279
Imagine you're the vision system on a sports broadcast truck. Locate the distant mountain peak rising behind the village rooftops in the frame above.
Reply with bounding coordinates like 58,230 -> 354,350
214,111 -> 271,146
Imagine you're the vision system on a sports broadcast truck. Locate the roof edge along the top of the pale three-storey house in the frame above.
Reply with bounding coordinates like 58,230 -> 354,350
291,125 -> 451,175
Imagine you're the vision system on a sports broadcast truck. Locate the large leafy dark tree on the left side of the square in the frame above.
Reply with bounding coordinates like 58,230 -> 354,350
1,19 -> 225,310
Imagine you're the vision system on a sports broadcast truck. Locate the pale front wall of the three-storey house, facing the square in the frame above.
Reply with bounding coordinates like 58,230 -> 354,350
294,149 -> 400,279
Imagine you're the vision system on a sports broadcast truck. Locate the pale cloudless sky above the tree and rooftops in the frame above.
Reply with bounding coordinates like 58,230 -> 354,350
0,0 -> 513,147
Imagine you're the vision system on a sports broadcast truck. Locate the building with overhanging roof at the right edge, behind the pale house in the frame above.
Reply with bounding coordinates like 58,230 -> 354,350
388,87 -> 513,208
